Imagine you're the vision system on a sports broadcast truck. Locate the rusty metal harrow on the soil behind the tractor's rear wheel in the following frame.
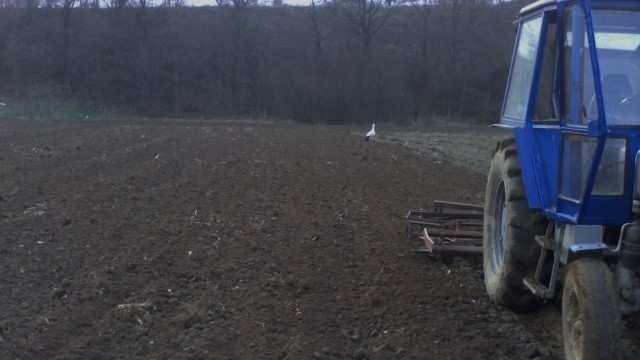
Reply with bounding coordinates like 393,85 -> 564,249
407,200 -> 484,254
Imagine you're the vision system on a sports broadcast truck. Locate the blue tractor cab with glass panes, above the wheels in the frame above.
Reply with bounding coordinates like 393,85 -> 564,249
500,0 -> 640,225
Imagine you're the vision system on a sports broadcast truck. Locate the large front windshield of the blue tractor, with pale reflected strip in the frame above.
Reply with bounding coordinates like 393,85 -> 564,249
590,10 -> 640,126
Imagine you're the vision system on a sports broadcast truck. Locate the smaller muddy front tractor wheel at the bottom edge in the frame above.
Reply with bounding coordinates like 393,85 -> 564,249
562,258 -> 622,360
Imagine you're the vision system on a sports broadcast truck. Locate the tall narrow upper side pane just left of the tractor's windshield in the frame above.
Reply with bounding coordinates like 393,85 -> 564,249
563,6 -> 597,126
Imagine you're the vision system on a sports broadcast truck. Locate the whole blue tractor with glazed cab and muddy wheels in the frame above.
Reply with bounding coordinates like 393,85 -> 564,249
482,0 -> 640,359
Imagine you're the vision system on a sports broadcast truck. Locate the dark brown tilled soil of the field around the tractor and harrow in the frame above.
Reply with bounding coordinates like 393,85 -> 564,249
0,121 -> 638,359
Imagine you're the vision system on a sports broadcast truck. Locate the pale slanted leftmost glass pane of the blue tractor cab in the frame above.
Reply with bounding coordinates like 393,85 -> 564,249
503,17 -> 542,120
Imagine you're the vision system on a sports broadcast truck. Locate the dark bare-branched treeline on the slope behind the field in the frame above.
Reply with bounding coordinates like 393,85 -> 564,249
0,0 -> 524,123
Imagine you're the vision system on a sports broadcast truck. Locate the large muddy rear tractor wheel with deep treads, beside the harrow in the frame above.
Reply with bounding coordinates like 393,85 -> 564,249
483,139 -> 547,312
